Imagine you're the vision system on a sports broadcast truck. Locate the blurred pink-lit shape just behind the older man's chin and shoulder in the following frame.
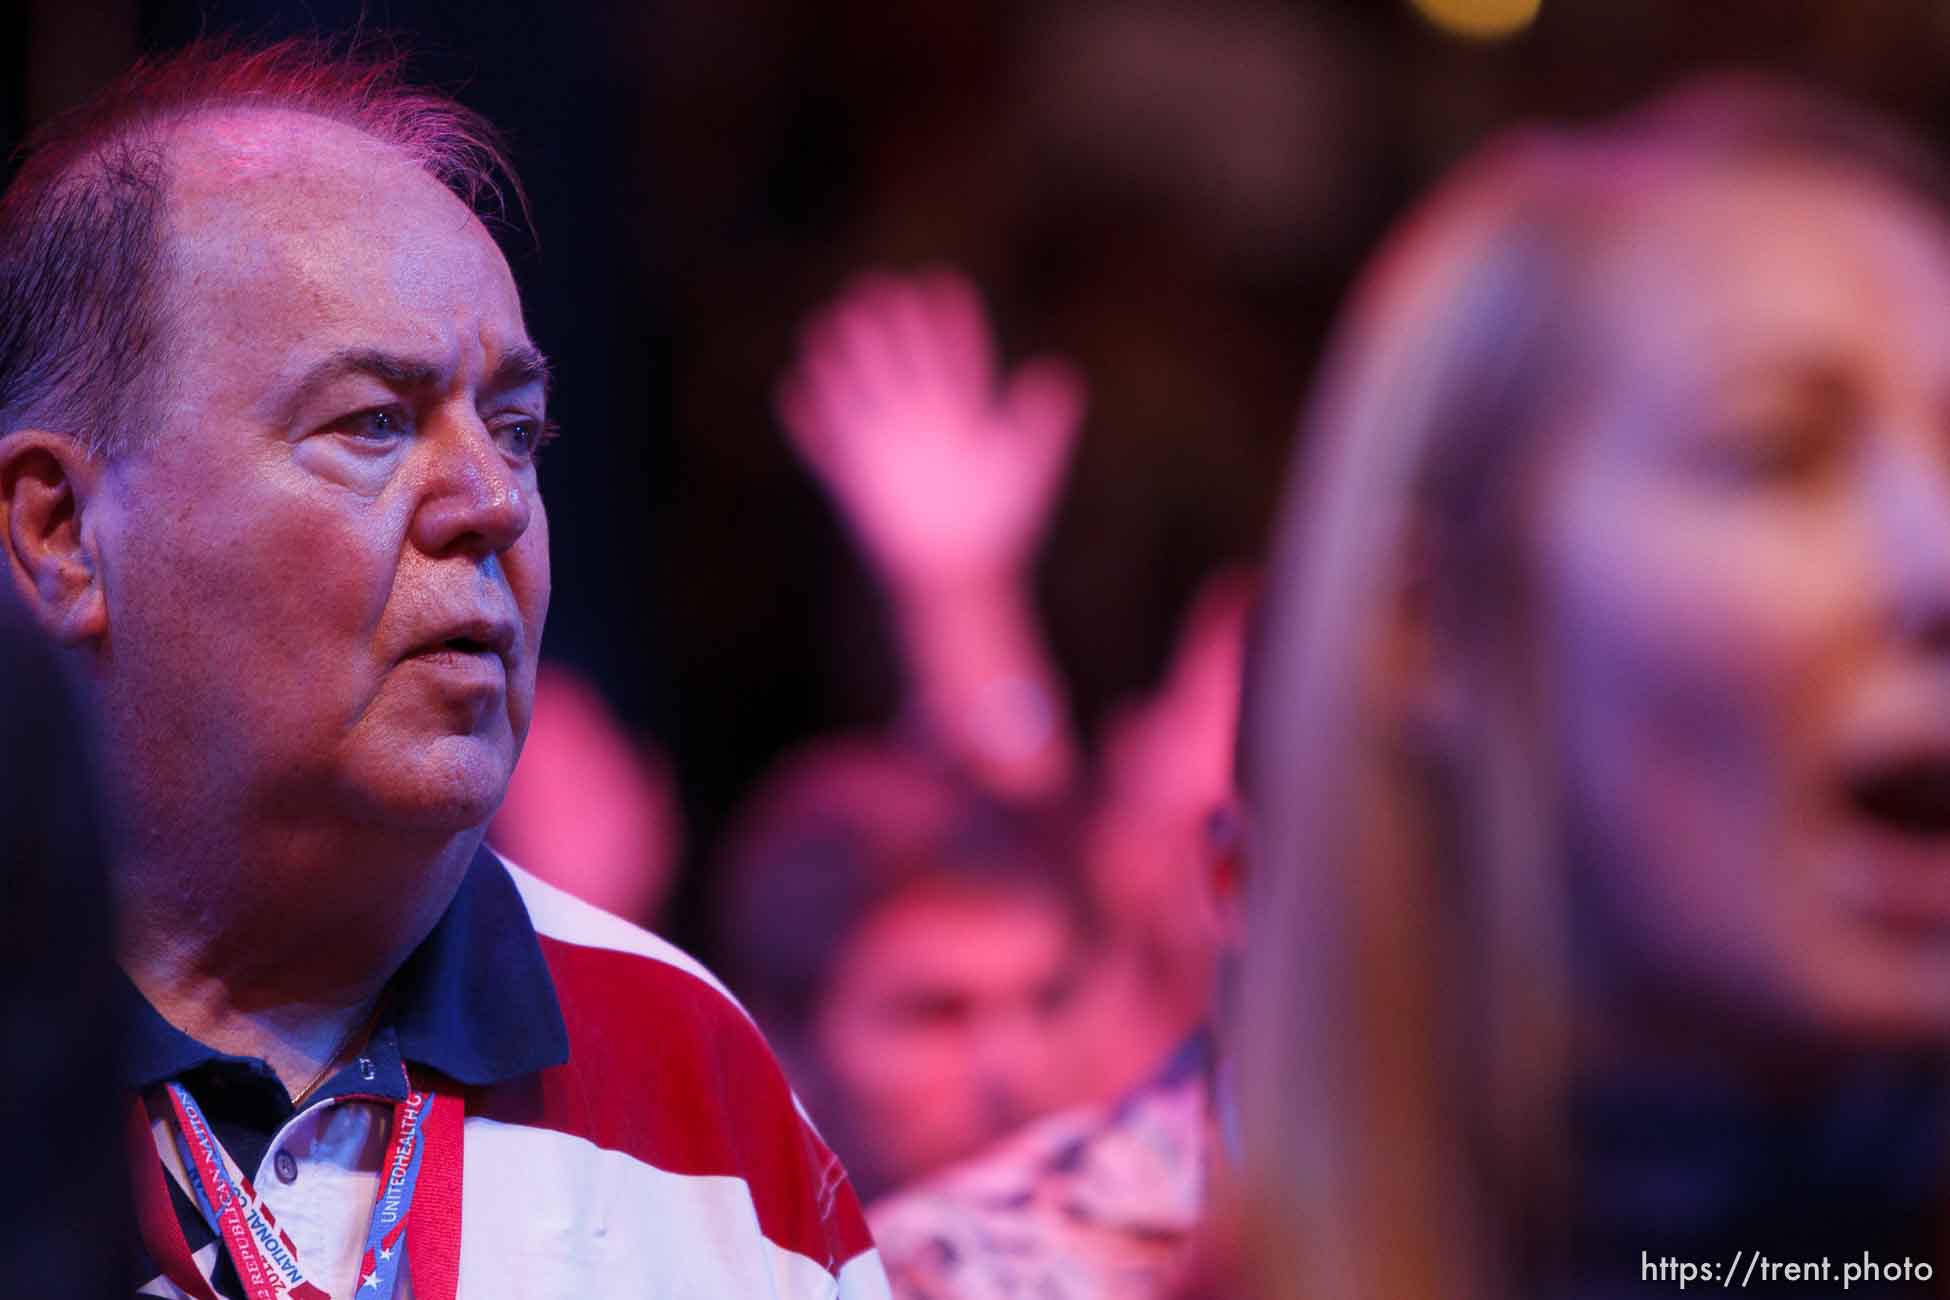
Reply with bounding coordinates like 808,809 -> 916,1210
488,663 -> 684,928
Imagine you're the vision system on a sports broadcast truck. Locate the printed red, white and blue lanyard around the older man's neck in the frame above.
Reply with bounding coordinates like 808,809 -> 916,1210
155,1080 -> 438,1300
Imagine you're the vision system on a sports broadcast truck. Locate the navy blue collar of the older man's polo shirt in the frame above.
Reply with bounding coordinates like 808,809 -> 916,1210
121,846 -> 569,1091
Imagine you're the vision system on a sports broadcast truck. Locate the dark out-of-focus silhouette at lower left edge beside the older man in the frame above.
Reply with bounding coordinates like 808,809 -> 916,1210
0,589 -> 135,1300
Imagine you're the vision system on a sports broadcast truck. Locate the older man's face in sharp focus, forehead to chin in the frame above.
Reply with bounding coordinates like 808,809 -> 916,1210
96,111 -> 548,830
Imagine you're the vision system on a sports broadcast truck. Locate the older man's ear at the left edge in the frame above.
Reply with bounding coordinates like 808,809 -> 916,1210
0,429 -> 109,645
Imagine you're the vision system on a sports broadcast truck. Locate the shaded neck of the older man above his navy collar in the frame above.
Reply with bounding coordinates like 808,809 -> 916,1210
115,814 -> 482,1095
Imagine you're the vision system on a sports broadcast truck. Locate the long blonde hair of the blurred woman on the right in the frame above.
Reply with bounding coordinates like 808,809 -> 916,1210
1238,80 -> 1944,1300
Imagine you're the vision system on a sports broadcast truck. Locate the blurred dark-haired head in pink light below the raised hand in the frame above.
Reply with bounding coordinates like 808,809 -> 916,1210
718,739 -> 1090,1199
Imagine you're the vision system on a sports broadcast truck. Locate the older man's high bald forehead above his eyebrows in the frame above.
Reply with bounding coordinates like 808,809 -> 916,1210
143,109 -> 530,448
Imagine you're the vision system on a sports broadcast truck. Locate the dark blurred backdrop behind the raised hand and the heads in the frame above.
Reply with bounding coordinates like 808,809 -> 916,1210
15,0 -> 1950,947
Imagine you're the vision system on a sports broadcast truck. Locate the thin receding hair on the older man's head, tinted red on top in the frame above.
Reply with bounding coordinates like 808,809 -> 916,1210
0,41 -> 521,456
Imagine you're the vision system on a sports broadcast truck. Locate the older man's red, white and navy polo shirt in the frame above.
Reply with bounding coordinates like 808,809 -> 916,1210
125,848 -> 887,1300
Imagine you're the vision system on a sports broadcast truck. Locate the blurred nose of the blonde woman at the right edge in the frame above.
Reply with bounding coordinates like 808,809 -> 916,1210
1870,439 -> 1950,657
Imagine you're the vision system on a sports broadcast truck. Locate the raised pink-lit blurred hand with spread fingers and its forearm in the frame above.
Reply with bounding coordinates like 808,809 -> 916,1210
778,271 -> 1084,795
